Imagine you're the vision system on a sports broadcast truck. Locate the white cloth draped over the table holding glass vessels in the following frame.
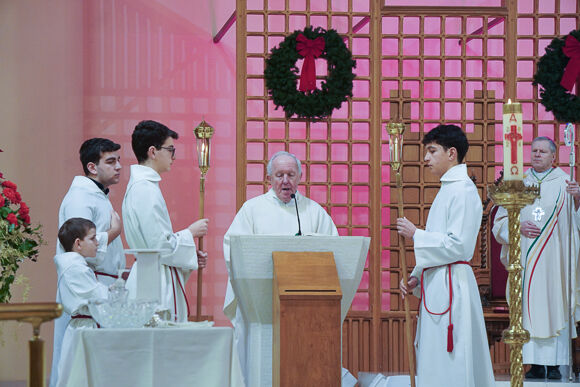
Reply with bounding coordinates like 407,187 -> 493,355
59,327 -> 244,387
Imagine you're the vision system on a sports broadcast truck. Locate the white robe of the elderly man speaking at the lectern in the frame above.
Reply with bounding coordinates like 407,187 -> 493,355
224,189 -> 338,382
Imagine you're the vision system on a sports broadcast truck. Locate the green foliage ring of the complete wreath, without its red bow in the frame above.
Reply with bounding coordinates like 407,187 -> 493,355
264,27 -> 356,120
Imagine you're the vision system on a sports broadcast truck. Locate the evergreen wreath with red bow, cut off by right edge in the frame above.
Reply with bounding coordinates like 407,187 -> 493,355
533,30 -> 580,123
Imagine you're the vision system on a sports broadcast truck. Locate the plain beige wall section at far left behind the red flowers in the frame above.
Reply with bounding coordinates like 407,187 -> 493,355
0,0 -> 82,384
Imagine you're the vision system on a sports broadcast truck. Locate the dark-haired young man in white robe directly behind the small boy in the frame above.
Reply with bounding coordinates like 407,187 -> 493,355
50,138 -> 125,386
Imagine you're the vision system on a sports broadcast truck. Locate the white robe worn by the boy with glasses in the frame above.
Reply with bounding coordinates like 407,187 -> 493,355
123,165 -> 197,322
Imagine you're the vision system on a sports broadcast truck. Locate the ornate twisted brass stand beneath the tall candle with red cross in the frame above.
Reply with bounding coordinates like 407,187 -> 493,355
488,180 -> 540,387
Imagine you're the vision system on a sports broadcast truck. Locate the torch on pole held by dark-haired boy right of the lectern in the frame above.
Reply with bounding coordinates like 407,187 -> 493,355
387,122 -> 415,387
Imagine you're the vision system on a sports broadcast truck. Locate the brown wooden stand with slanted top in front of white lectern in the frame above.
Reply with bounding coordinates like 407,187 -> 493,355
272,251 -> 342,387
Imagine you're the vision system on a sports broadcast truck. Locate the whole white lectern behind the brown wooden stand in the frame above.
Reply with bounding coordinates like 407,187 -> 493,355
226,235 -> 370,387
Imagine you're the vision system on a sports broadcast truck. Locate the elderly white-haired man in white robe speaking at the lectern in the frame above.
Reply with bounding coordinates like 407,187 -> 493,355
224,151 -> 338,380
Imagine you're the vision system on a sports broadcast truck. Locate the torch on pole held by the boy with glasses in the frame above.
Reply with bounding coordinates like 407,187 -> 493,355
193,120 -> 214,321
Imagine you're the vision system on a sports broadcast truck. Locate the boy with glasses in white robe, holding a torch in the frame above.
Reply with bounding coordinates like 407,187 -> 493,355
123,121 -> 208,322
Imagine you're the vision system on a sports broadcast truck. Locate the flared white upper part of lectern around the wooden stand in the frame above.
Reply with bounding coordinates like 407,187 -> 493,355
230,235 -> 371,324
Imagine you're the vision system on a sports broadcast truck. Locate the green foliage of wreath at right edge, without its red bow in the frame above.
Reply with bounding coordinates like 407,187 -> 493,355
533,30 -> 580,123
